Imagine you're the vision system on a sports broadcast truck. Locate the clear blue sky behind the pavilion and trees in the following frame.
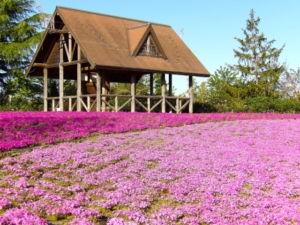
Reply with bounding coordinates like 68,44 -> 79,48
36,0 -> 300,94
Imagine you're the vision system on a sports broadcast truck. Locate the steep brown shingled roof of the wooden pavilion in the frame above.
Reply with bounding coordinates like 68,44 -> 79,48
28,7 -> 209,77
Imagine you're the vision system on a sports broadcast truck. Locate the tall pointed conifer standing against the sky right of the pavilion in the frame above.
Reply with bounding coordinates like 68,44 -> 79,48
233,9 -> 285,96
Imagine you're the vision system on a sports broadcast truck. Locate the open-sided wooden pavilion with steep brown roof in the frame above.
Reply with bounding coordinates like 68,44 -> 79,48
26,7 -> 209,113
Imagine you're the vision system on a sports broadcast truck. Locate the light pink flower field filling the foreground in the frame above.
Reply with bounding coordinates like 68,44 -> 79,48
0,118 -> 300,225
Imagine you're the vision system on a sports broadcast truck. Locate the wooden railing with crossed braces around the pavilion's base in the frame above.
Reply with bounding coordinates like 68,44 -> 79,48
47,94 -> 190,113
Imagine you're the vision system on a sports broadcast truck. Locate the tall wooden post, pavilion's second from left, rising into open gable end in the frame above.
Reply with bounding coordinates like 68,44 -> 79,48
59,34 -> 64,111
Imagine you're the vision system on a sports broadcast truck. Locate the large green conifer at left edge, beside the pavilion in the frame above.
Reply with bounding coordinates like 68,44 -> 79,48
0,0 -> 42,109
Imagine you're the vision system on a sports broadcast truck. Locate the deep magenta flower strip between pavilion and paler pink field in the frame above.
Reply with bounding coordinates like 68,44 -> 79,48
0,112 -> 299,151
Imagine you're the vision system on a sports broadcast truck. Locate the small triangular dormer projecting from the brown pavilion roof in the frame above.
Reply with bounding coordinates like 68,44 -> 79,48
128,24 -> 167,59
